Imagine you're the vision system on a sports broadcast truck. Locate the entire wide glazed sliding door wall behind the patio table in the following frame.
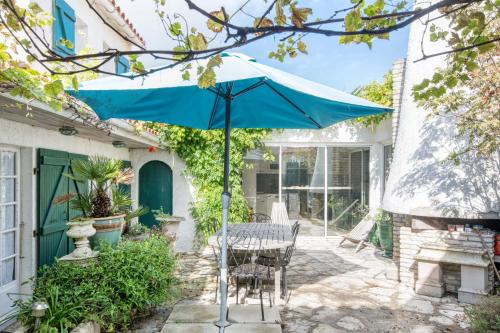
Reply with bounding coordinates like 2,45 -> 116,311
243,145 -> 370,236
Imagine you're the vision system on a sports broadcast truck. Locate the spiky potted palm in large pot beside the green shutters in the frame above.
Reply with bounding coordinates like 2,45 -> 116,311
61,156 -> 144,247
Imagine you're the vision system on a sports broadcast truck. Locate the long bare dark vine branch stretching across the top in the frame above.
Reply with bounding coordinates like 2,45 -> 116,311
4,0 -> 482,77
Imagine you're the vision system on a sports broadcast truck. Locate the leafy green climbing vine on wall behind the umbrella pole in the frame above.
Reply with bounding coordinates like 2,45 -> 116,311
147,123 -> 271,238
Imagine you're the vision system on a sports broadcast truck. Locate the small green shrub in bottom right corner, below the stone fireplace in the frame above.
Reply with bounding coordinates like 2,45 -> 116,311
465,295 -> 500,333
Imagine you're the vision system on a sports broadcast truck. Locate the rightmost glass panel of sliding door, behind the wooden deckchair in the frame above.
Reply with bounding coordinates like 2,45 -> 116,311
326,147 -> 370,236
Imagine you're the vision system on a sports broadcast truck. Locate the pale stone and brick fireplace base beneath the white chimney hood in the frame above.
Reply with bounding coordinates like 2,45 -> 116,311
393,214 -> 495,303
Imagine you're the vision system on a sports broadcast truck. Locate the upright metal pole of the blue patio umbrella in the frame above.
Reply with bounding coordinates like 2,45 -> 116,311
215,94 -> 231,333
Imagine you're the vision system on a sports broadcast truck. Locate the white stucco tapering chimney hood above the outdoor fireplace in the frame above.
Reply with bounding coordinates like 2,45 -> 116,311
383,4 -> 500,218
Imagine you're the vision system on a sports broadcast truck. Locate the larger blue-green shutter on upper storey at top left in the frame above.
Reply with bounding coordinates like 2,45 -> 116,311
52,0 -> 76,57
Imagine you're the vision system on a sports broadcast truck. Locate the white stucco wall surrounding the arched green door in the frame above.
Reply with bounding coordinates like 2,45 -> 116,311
130,149 -> 195,251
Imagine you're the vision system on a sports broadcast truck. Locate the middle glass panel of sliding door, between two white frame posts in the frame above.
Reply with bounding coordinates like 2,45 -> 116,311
281,147 -> 325,236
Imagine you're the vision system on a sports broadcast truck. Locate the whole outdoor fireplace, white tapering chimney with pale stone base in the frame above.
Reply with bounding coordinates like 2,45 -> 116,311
382,50 -> 500,303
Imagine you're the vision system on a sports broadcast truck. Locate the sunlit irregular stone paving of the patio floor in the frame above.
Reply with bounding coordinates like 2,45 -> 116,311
158,238 -> 468,333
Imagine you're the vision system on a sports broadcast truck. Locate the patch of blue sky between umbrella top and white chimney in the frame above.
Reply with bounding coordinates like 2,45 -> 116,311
235,29 -> 408,92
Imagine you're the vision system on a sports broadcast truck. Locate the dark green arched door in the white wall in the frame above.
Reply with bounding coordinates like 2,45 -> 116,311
139,161 -> 172,228
